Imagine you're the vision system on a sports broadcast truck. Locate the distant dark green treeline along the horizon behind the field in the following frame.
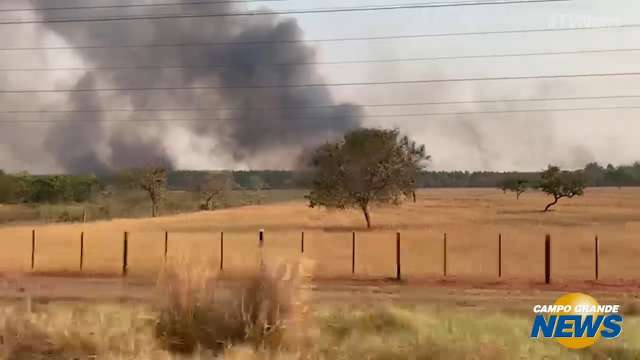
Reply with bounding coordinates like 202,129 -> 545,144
0,162 -> 640,203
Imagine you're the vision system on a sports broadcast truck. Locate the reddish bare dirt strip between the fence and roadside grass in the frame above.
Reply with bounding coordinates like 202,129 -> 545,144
5,274 -> 640,312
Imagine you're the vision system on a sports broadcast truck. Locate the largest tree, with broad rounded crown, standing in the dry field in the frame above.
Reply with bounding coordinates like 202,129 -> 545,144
306,129 -> 429,228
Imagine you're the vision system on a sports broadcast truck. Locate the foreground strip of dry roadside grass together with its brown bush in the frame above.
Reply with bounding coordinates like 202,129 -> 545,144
0,260 -> 640,360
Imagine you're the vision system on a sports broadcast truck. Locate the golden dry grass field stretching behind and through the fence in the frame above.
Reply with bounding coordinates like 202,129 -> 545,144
0,188 -> 640,280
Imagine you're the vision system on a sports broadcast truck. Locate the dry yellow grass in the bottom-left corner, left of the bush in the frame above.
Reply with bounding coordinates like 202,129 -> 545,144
0,305 -> 156,360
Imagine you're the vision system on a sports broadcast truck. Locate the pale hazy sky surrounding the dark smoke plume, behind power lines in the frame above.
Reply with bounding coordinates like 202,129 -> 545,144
0,0 -> 640,172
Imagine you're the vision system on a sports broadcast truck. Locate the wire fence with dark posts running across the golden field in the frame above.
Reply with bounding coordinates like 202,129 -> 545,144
14,229 -> 616,284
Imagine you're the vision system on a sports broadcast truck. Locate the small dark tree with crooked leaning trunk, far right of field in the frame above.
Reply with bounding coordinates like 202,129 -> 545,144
538,165 -> 586,212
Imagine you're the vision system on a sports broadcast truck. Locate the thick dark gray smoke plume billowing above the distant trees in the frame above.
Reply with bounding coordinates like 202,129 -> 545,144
33,0 -> 361,172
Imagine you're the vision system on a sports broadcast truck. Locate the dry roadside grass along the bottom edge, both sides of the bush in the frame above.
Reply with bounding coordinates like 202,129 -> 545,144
0,303 -> 640,360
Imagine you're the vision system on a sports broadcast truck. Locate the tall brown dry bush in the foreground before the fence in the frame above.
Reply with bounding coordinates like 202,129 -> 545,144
155,258 -> 316,354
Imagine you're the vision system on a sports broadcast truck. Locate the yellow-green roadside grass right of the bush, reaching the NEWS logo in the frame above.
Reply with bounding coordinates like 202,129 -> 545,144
316,306 -> 640,360
